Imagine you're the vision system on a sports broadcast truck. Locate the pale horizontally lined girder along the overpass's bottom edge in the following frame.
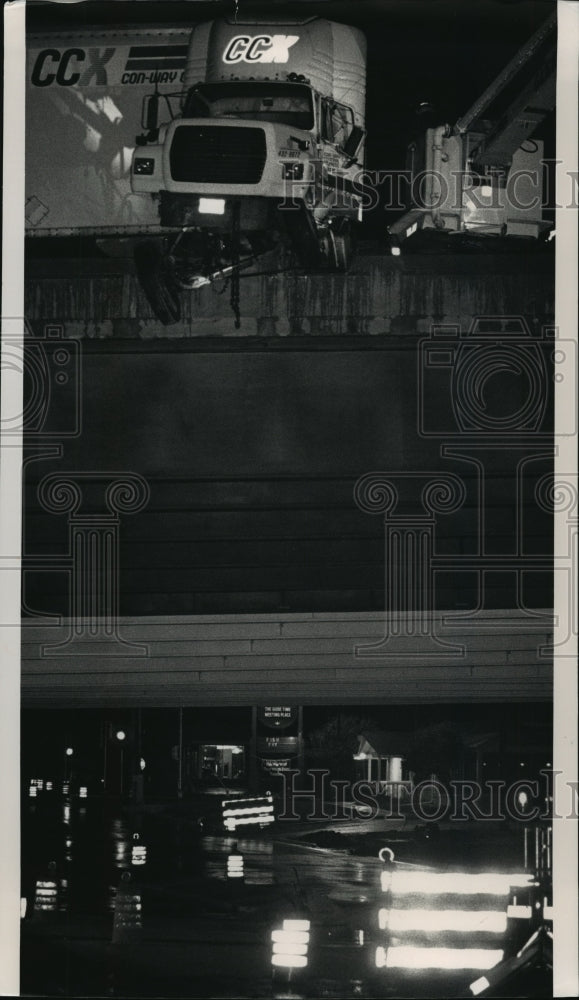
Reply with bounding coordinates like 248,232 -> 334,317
22,612 -> 552,708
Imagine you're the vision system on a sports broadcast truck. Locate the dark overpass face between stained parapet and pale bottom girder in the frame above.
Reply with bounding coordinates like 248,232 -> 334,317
24,334 -> 552,615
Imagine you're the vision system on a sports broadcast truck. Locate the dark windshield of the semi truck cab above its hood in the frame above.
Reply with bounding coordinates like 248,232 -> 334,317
183,81 -> 314,132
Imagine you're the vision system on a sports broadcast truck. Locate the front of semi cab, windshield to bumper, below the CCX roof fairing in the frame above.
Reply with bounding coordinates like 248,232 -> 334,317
133,81 -> 363,231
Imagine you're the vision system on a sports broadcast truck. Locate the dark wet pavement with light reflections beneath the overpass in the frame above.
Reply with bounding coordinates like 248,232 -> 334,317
21,795 -> 548,998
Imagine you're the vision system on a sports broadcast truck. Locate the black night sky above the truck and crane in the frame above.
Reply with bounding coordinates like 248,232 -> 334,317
27,0 -> 553,137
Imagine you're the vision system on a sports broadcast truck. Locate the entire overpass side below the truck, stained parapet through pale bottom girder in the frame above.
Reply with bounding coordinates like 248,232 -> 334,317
22,247 -> 554,707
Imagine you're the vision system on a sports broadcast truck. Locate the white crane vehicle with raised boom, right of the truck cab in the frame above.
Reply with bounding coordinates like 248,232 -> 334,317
388,13 -> 557,249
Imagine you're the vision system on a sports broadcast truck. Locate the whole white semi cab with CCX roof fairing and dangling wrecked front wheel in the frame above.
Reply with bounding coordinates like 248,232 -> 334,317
131,17 -> 366,322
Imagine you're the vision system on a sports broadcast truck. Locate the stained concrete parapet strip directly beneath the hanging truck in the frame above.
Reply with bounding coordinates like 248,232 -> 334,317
26,252 -> 554,339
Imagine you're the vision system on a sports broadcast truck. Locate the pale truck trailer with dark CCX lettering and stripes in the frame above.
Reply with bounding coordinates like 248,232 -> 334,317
25,27 -> 191,240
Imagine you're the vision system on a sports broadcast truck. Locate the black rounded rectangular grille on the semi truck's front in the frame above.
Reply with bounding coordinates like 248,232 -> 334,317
170,125 -> 266,184
